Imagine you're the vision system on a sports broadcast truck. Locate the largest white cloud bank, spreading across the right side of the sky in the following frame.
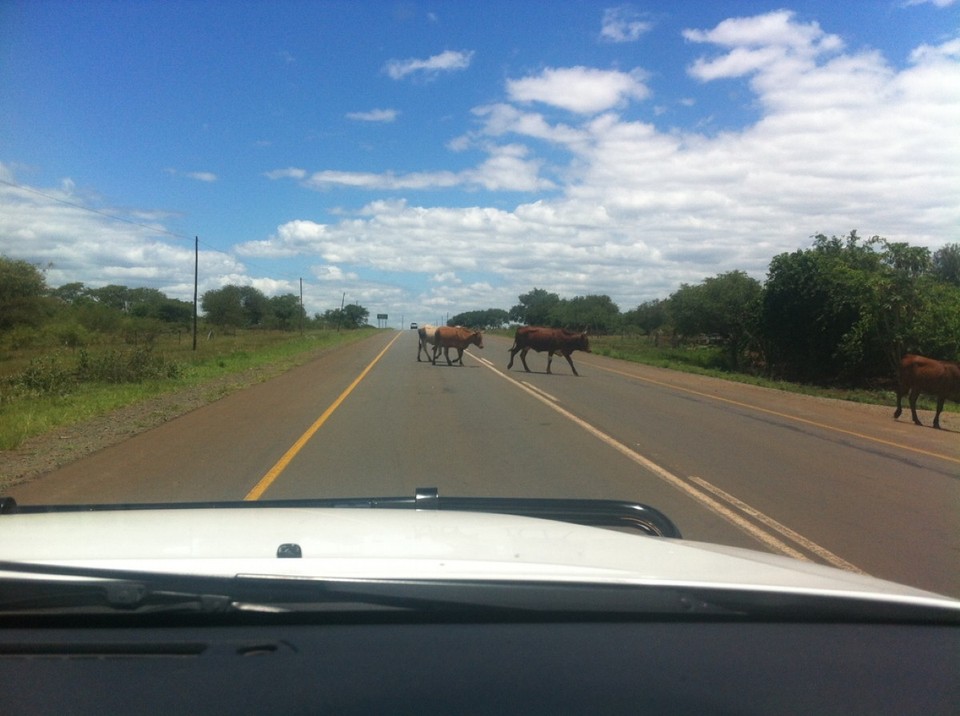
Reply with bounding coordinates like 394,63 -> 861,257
249,12 -> 960,309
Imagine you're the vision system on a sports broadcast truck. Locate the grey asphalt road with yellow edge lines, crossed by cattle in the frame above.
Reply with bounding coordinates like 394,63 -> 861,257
10,331 -> 960,596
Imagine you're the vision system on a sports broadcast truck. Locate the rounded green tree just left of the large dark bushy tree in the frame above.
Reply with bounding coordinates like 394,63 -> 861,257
670,271 -> 762,370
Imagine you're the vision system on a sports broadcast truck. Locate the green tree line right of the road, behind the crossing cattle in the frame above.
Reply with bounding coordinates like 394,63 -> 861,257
449,231 -> 960,385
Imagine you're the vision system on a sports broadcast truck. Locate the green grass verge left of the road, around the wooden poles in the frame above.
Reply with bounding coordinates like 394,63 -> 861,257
0,328 -> 377,450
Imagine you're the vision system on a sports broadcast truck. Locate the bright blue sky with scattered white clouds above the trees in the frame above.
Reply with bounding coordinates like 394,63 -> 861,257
0,0 -> 960,326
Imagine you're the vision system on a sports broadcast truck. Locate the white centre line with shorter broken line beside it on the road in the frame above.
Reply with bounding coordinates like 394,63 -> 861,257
476,361 -> 865,574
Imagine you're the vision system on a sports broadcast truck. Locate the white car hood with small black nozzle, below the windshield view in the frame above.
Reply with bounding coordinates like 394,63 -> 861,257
0,507 -> 960,611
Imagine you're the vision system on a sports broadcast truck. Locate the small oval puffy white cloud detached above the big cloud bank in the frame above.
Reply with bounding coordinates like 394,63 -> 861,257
507,67 -> 649,114
